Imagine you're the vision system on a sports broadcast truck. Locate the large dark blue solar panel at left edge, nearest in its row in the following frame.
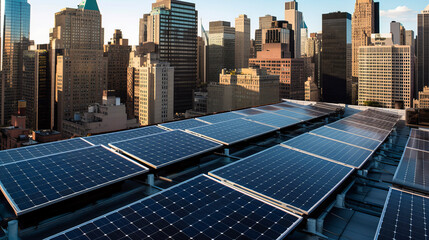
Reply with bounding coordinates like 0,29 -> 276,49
0,146 -> 148,215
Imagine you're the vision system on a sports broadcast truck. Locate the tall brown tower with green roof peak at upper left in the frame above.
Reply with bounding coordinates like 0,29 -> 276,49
51,0 -> 108,131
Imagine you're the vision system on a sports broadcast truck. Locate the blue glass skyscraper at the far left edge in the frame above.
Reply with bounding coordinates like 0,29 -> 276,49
0,0 -> 30,125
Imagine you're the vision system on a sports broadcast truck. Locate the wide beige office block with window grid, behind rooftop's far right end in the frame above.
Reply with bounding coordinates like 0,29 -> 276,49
359,42 -> 414,108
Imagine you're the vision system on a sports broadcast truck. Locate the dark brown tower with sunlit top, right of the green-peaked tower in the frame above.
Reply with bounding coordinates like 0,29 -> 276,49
104,29 -> 131,103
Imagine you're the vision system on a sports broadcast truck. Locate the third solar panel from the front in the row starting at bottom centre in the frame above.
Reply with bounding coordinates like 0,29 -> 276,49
282,134 -> 372,168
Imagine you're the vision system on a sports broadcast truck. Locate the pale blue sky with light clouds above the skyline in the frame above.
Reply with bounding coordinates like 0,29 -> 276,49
28,0 -> 429,45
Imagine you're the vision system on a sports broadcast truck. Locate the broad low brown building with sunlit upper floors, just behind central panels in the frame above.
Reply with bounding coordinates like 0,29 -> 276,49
207,68 -> 279,113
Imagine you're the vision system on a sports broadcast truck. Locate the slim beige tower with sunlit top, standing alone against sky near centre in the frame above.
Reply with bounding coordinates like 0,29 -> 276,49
235,14 -> 250,68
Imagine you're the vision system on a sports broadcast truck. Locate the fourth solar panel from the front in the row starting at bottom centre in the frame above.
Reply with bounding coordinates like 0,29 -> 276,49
312,127 -> 381,151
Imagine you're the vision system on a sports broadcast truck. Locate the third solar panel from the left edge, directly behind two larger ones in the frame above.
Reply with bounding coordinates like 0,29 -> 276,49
188,119 -> 277,145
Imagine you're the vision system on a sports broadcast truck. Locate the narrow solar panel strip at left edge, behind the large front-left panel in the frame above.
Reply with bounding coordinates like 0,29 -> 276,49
0,138 -> 91,165
